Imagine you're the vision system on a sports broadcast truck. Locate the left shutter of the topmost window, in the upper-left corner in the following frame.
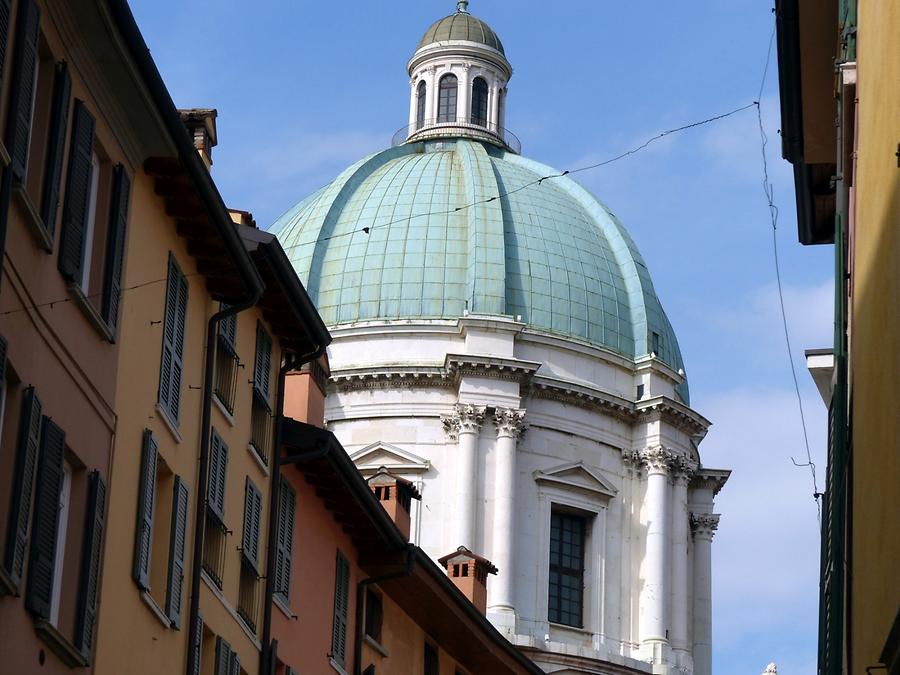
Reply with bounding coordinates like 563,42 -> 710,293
6,0 -> 41,183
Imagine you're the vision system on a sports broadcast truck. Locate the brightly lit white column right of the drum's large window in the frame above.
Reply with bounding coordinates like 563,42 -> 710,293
638,446 -> 674,663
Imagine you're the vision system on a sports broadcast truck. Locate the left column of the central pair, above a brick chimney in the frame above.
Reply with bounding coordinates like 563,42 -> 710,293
443,403 -> 484,551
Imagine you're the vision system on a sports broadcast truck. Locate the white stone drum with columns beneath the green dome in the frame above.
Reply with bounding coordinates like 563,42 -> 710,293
326,316 -> 728,675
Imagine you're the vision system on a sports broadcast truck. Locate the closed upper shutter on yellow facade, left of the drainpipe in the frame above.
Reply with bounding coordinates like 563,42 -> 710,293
159,254 -> 188,424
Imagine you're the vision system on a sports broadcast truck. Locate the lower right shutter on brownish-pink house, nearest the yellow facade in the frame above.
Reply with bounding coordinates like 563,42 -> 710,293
75,471 -> 106,660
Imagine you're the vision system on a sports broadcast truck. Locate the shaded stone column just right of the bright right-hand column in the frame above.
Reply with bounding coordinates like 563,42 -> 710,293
669,458 -> 695,668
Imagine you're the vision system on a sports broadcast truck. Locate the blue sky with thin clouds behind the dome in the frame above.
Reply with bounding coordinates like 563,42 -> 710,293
132,0 -> 833,675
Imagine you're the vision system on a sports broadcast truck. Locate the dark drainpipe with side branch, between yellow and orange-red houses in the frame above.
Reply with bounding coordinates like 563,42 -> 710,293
259,346 -> 328,675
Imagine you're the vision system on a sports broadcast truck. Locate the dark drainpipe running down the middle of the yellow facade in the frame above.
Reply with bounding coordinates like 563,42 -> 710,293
185,298 -> 262,675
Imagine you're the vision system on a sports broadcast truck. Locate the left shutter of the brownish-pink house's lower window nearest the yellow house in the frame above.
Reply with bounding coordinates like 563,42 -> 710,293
25,417 -> 66,619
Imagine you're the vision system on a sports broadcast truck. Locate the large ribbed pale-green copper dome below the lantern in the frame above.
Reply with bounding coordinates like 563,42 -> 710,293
272,139 -> 687,401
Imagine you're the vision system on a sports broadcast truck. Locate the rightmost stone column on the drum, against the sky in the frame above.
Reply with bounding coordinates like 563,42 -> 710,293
691,513 -> 719,675
